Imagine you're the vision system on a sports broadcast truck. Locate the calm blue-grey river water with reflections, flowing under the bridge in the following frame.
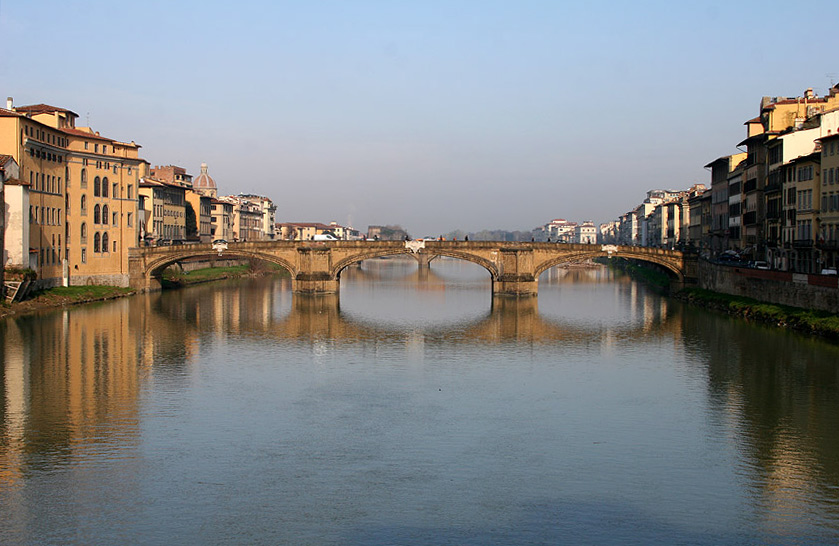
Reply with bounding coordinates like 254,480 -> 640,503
0,258 -> 839,545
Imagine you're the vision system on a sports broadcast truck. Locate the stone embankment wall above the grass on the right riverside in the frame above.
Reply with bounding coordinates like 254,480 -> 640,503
699,260 -> 839,313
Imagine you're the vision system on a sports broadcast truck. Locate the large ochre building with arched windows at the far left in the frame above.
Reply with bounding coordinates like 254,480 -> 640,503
0,99 -> 143,286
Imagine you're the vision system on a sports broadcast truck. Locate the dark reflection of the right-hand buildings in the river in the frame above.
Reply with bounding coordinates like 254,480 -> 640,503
684,311 -> 839,524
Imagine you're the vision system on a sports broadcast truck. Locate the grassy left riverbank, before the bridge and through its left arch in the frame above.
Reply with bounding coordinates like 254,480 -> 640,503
0,264 -> 288,318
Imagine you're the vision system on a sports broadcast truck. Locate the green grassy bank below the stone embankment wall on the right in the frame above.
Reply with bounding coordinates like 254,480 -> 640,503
676,288 -> 839,339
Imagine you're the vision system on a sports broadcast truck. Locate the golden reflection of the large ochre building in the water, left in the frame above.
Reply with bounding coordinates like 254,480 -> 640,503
0,300 -> 139,485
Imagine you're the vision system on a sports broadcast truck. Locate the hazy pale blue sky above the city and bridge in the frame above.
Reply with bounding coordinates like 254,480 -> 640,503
0,0 -> 839,237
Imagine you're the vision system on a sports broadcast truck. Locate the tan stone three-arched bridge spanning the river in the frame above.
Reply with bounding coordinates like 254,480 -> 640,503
128,241 -> 697,296
